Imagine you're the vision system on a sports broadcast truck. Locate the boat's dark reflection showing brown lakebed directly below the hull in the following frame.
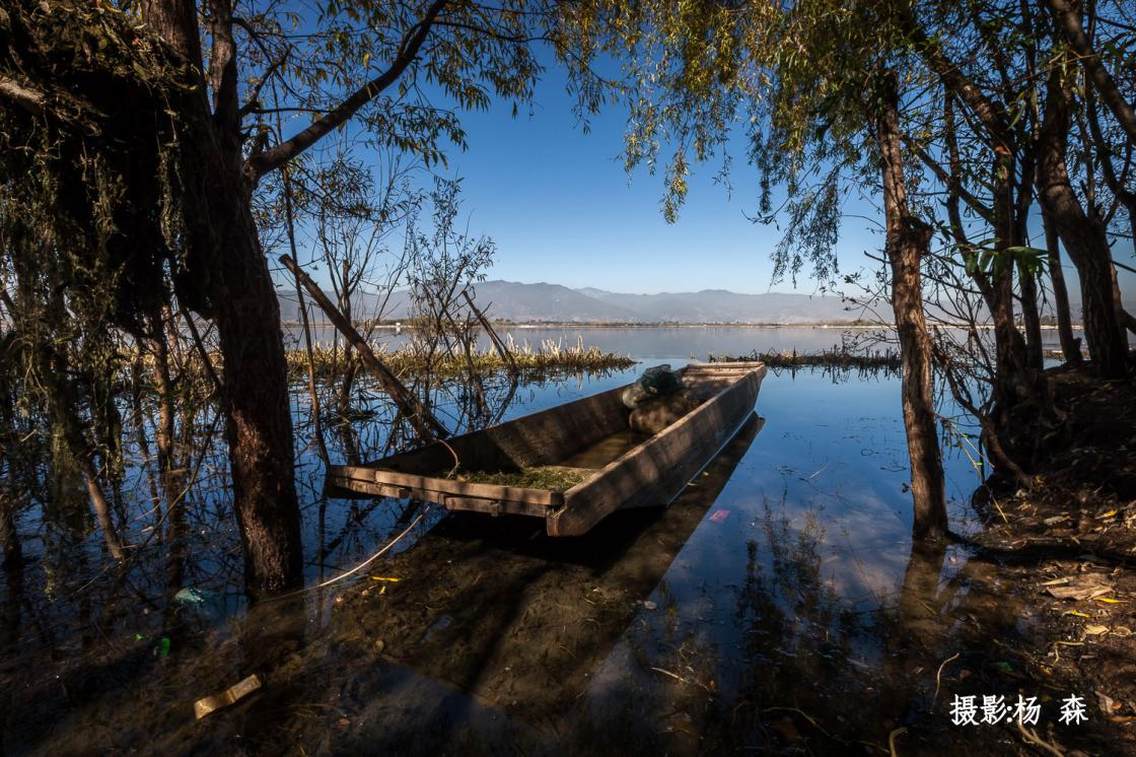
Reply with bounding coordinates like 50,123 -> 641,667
320,417 -> 761,744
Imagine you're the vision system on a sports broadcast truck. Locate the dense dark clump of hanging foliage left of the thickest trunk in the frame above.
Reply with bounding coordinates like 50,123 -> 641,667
0,1 -> 219,332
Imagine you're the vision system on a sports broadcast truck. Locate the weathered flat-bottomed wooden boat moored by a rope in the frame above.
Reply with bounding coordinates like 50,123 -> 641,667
327,363 -> 766,536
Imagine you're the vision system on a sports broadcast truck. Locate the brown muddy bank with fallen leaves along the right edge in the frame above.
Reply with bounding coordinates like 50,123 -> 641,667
922,368 -> 1136,754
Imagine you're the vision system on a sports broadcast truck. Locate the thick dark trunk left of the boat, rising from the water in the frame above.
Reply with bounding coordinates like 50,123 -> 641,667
142,0 -> 303,598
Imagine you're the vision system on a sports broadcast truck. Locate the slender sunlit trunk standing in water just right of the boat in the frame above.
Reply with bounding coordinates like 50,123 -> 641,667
876,73 -> 947,540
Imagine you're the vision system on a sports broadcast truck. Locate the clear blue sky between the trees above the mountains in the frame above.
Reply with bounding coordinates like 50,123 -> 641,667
402,61 -> 879,293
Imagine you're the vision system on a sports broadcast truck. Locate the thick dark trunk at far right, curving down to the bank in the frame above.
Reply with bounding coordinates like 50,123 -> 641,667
1037,66 -> 1128,379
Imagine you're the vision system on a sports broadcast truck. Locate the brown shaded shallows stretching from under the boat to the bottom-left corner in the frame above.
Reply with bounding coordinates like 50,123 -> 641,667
6,416 -> 762,754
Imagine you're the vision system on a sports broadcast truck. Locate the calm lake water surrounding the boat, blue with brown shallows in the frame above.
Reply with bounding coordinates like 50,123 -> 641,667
0,328 -> 1031,754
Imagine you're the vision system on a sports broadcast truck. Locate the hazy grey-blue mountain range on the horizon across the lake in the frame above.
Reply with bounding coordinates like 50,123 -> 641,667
281,281 -> 892,324
